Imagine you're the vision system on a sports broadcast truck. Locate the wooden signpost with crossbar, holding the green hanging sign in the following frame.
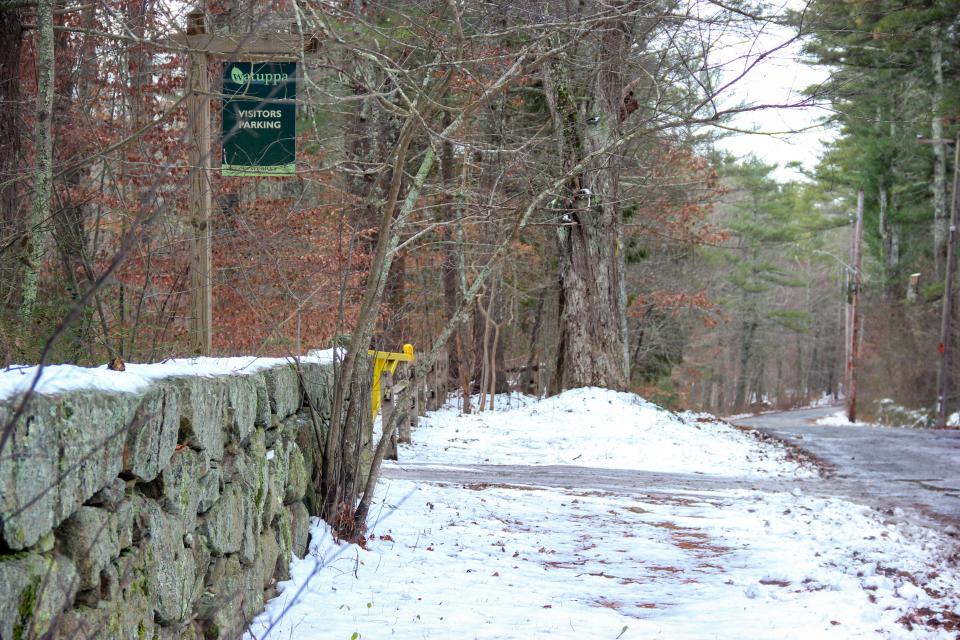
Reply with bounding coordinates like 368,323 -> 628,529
171,11 -> 317,356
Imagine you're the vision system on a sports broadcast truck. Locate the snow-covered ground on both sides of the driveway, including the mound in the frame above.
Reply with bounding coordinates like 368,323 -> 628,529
247,390 -> 960,640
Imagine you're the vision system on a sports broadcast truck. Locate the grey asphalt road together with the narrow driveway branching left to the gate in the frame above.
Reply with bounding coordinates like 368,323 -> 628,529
383,407 -> 960,532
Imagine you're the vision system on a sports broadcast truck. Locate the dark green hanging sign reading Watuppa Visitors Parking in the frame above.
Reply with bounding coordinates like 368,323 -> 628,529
220,62 -> 297,176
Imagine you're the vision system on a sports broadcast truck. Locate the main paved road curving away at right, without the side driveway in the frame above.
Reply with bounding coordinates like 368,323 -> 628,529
736,407 -> 960,526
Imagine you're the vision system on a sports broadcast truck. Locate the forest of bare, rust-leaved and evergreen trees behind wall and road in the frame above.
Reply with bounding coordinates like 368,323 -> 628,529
0,0 -> 960,415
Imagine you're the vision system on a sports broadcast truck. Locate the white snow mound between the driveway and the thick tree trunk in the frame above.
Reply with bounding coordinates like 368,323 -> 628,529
400,387 -> 815,477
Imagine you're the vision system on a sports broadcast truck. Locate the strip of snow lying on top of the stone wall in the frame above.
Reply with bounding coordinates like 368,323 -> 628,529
0,350 -> 333,400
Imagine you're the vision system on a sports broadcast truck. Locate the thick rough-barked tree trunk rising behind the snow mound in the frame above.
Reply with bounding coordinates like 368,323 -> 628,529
555,8 -> 631,389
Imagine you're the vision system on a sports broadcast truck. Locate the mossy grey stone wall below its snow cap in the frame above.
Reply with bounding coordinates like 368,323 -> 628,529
0,364 -> 370,640
